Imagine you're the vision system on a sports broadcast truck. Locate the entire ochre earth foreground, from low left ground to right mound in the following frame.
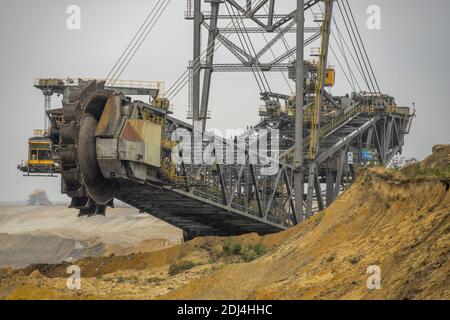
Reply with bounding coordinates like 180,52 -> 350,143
0,146 -> 450,299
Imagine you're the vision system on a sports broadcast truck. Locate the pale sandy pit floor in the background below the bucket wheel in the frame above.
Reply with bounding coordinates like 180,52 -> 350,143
0,206 -> 182,268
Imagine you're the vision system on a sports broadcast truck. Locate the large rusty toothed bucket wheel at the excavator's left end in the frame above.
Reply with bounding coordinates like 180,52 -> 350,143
58,81 -> 115,216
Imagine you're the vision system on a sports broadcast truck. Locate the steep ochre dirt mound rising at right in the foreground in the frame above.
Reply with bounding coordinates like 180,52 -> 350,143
167,170 -> 450,299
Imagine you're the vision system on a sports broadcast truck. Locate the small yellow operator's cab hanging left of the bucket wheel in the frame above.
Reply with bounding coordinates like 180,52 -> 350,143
18,132 -> 59,175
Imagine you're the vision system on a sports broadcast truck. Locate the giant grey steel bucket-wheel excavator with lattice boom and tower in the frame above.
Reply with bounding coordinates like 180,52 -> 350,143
21,0 -> 413,238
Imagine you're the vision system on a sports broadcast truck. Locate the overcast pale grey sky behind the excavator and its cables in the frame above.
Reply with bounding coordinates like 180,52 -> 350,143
0,0 -> 450,201
